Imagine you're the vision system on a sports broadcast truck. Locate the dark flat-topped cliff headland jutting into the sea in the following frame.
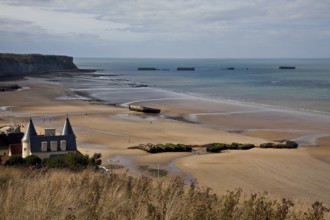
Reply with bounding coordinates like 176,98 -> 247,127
0,53 -> 78,76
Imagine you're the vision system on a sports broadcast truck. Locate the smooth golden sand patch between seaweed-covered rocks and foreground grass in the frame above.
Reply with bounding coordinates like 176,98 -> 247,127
176,149 -> 330,204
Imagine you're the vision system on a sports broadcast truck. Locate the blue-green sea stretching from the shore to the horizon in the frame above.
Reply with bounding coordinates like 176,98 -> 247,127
74,58 -> 330,114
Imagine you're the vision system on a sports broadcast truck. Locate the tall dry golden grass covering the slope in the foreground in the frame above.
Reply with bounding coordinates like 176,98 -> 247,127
0,167 -> 329,220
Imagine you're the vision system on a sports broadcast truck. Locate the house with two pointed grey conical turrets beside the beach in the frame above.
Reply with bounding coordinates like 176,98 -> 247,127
22,118 -> 77,159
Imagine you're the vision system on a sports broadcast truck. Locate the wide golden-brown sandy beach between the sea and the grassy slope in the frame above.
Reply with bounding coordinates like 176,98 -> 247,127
0,72 -> 330,205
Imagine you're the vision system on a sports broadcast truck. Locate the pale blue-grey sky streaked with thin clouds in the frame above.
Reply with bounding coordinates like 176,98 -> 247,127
0,0 -> 330,58
